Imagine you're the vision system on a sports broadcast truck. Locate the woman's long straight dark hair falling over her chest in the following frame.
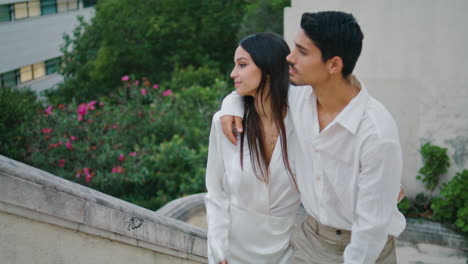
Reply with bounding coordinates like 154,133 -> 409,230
239,33 -> 294,182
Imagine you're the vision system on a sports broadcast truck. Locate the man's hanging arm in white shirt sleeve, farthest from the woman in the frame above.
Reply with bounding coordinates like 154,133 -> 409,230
344,138 -> 402,264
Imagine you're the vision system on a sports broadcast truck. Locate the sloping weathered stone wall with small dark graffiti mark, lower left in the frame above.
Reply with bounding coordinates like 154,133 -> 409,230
0,156 -> 207,264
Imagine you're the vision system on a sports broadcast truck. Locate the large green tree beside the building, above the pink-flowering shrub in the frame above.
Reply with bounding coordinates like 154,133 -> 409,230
49,0 -> 246,101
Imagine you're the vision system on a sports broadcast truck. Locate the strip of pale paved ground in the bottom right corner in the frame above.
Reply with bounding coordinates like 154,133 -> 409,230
396,240 -> 468,264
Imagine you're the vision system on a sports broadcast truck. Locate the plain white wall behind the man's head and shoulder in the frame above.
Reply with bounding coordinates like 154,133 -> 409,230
284,0 -> 468,196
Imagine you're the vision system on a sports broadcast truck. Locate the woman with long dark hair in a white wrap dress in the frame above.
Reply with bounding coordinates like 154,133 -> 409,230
205,33 -> 300,264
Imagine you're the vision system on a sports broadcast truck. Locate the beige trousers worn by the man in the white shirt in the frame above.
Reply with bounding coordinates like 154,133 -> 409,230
291,216 -> 396,264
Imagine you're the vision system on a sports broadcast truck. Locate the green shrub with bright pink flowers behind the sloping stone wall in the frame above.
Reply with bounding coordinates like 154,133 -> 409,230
25,71 -> 228,209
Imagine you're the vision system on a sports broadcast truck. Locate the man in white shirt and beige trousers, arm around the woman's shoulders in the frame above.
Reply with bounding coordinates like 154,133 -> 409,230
222,11 -> 405,264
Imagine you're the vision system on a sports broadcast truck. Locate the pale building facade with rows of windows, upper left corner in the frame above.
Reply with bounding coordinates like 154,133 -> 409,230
0,0 -> 96,91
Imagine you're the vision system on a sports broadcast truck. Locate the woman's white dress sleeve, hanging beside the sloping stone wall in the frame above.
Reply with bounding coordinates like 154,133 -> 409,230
205,112 -> 231,264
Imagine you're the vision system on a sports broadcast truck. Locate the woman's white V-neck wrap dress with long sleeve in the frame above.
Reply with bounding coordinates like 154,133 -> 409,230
205,113 -> 300,264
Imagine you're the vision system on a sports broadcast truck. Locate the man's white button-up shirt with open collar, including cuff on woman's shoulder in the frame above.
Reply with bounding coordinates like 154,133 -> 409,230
220,80 -> 406,264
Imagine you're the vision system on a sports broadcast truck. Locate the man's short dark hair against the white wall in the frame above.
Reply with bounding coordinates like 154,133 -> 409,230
301,11 -> 364,77
